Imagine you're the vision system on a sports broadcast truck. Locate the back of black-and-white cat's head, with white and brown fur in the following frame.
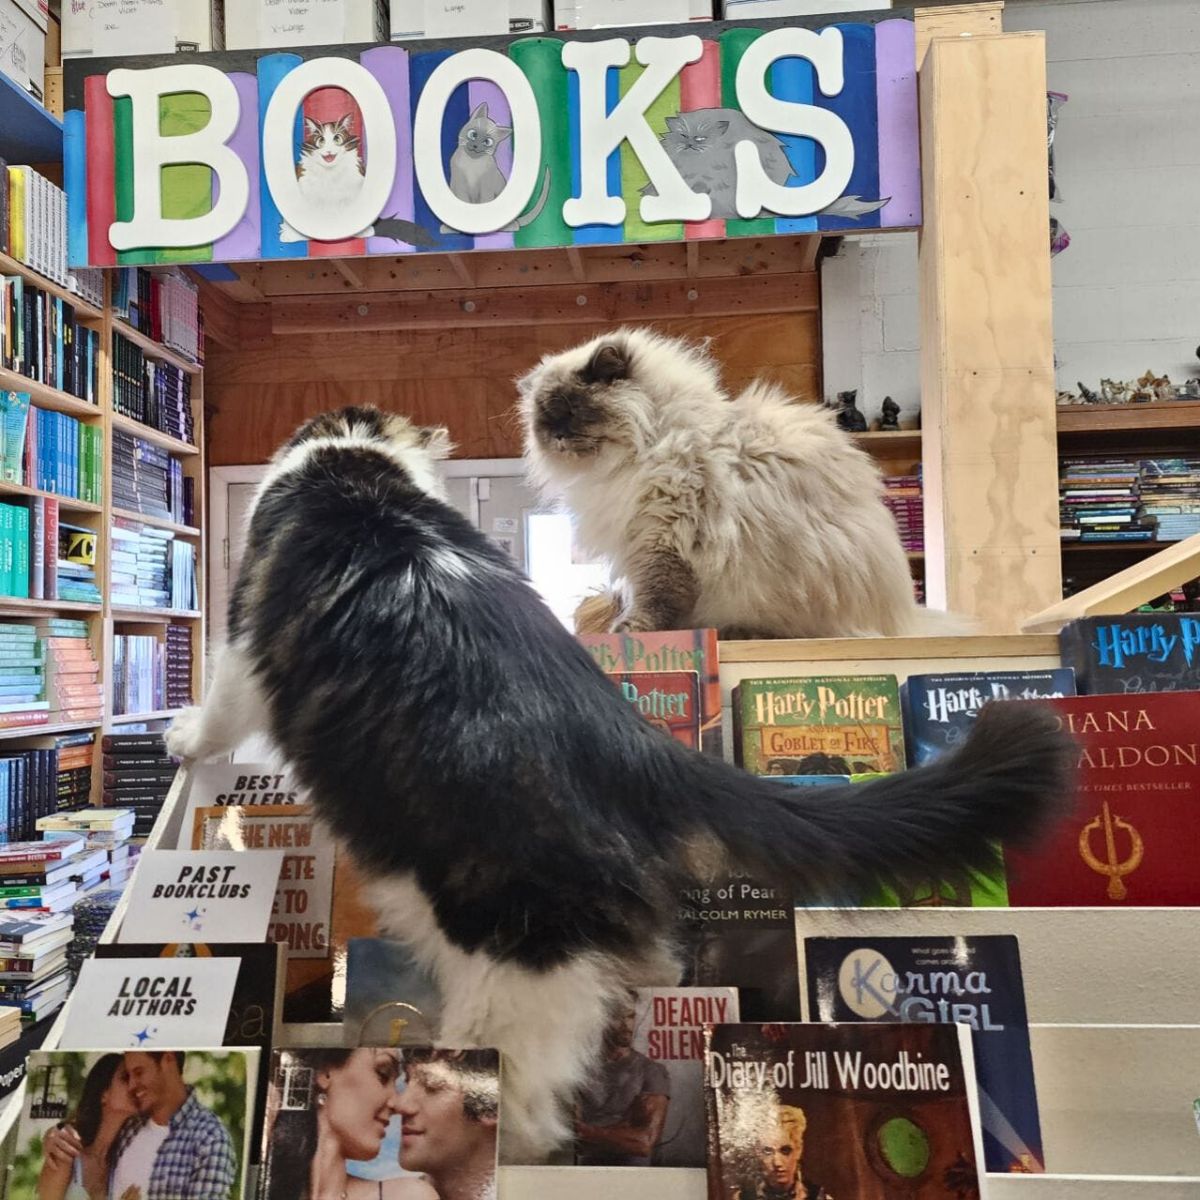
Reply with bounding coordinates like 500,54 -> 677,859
272,406 -> 454,499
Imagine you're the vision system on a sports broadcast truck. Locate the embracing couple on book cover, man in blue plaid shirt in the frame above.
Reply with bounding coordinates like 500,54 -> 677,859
37,1050 -> 244,1200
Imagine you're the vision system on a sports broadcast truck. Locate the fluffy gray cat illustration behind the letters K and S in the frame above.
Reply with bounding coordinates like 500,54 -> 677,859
642,108 -> 888,220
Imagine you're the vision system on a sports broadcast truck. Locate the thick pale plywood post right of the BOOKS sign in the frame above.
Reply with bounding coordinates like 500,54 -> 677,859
920,34 -> 1062,634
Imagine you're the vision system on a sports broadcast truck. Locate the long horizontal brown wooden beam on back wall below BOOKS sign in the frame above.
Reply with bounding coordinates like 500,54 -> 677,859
271,272 -> 818,335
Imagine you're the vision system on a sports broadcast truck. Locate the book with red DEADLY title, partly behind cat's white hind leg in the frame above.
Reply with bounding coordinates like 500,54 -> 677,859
575,988 -> 739,1166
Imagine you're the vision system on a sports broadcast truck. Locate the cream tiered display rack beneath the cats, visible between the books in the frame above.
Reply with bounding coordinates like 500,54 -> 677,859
0,636 -> 1200,1200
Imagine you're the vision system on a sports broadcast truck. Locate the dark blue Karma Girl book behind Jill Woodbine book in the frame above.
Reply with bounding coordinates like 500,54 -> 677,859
804,935 -> 1045,1174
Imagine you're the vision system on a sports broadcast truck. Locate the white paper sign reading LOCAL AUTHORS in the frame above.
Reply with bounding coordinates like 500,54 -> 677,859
59,959 -> 241,1050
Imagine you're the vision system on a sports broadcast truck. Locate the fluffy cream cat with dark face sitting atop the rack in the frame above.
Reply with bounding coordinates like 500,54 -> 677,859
518,329 -> 955,637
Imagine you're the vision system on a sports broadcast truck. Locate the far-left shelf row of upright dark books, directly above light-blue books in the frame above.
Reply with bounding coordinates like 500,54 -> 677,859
0,275 -> 100,404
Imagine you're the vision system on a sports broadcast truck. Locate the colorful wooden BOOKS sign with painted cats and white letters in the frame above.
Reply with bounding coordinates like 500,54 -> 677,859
65,17 -> 920,266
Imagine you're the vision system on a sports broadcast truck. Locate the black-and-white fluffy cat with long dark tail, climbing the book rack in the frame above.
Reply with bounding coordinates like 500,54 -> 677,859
168,408 -> 1072,1160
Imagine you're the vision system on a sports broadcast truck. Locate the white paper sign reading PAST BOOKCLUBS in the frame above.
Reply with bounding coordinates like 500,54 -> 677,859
118,850 -> 283,942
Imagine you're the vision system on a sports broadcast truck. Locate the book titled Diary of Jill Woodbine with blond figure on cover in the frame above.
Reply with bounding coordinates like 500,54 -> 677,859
704,1024 -> 984,1200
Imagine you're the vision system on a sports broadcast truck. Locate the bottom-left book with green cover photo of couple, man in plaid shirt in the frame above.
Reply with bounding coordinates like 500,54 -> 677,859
8,1045 -> 259,1200
